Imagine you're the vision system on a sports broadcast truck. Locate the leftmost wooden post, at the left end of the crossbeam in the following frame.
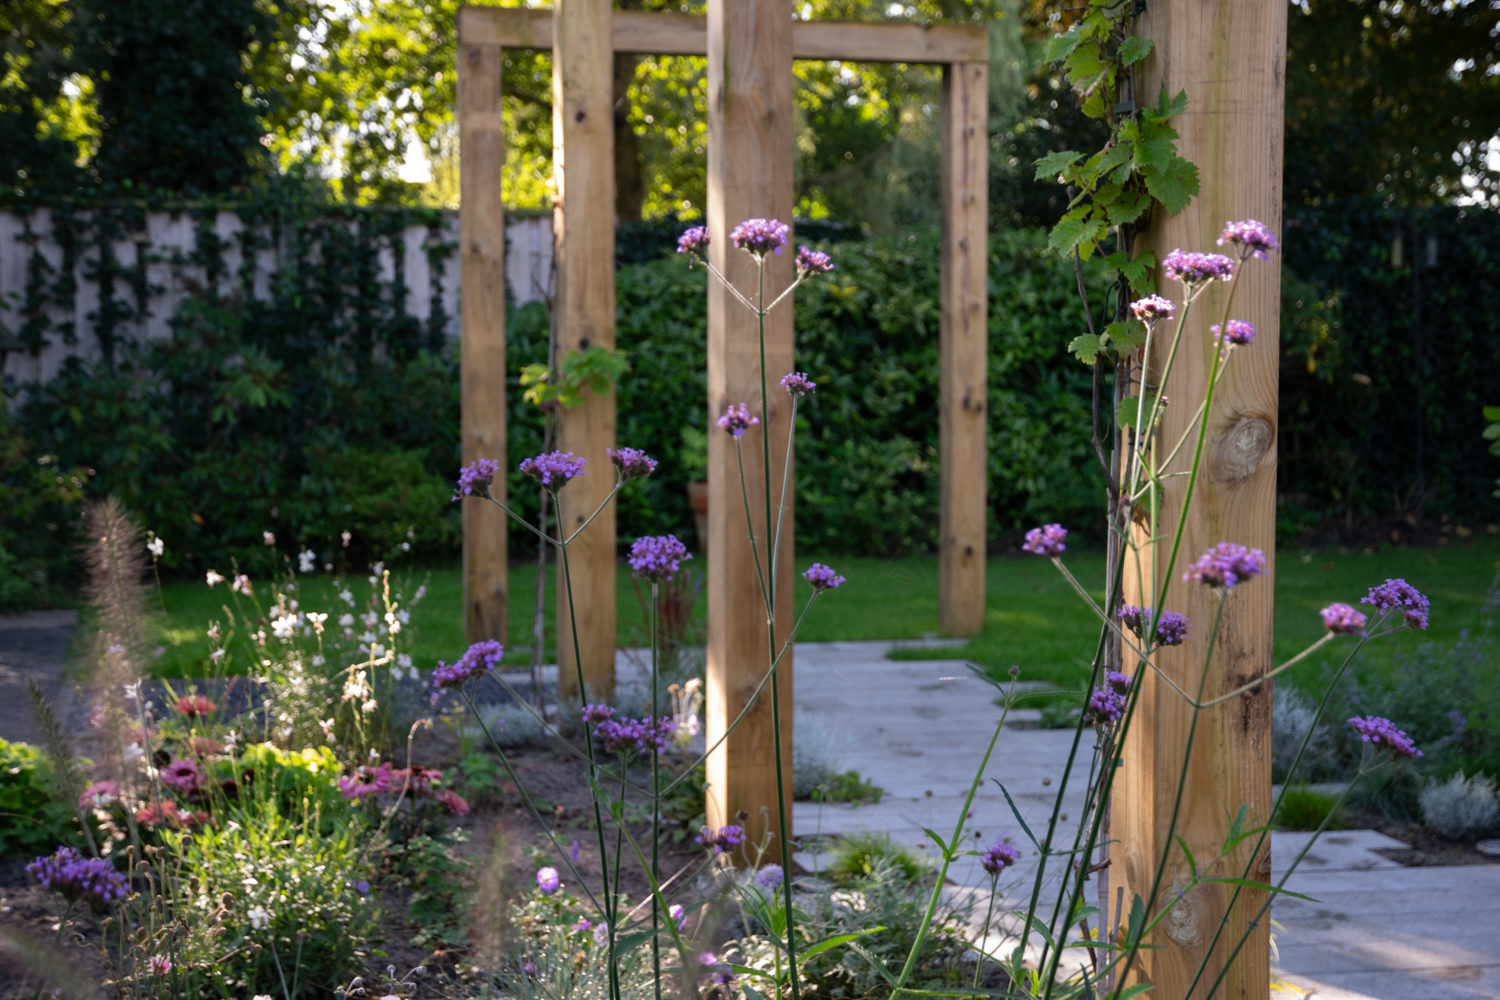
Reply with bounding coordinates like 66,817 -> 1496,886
458,27 -> 510,643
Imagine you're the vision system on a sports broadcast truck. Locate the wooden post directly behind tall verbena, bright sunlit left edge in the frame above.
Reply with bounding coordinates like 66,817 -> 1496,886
705,0 -> 794,853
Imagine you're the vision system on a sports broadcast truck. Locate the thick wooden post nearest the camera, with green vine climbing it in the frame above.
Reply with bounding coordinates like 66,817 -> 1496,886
1113,0 -> 1287,1000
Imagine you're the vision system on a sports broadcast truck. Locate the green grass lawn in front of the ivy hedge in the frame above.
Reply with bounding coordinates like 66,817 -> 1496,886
143,535 -> 1500,695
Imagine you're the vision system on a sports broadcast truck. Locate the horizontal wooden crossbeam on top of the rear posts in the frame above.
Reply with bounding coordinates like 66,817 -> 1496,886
459,7 -> 990,64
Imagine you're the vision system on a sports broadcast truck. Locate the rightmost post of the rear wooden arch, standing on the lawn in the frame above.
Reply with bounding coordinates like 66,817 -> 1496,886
938,63 -> 990,636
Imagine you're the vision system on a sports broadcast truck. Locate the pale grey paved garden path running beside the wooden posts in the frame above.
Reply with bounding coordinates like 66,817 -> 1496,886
794,642 -> 1500,1000
